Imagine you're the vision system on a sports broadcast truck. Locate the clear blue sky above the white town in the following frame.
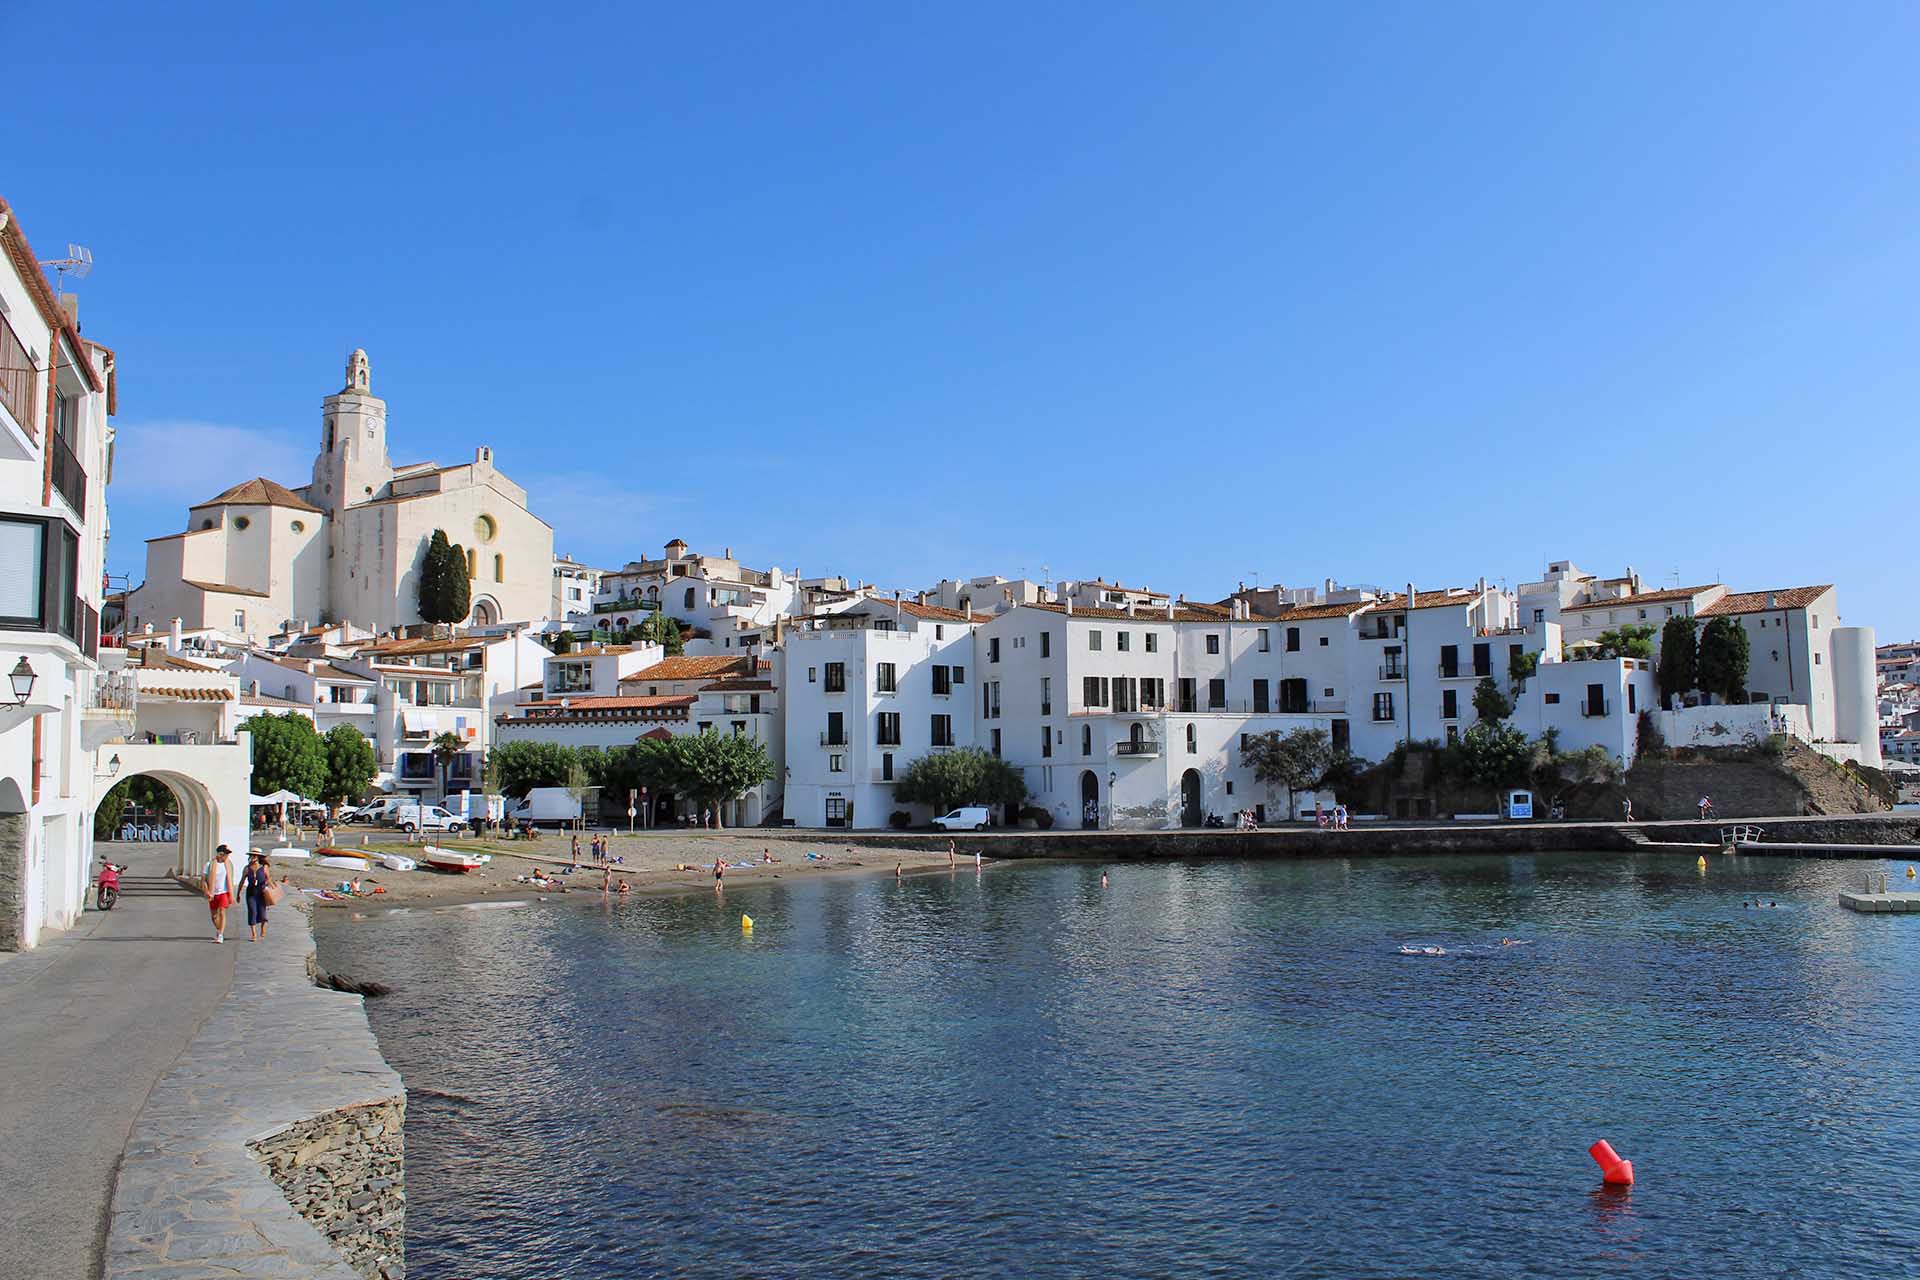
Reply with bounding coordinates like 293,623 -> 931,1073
15,4 -> 1920,641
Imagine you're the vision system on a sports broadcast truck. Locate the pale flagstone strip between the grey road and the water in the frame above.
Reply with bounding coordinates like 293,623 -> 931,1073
106,902 -> 405,1280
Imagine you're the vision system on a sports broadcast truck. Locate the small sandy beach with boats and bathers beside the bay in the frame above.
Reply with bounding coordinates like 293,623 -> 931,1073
270,827 -> 998,910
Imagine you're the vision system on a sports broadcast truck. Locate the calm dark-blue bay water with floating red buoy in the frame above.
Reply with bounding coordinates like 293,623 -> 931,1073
321,856 -> 1920,1280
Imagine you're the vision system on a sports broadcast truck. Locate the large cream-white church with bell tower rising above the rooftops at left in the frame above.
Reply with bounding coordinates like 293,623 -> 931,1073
127,351 -> 553,643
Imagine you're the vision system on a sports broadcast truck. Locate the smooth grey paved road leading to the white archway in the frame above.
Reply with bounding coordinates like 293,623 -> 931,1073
0,844 -> 246,1280
